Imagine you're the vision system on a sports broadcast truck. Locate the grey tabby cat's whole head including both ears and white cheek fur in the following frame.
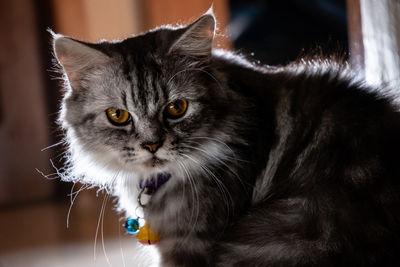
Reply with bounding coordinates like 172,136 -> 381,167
54,13 -> 242,188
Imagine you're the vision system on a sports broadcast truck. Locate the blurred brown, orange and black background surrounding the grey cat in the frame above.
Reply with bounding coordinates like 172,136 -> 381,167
0,0 -> 400,267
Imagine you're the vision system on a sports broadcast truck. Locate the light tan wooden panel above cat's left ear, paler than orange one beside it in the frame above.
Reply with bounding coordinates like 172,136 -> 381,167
51,0 -> 143,42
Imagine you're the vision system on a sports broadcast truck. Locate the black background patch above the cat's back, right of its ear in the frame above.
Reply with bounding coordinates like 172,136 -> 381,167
230,0 -> 348,65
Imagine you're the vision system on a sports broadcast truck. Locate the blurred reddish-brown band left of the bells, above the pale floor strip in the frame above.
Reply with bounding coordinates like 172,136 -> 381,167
0,190 -> 125,251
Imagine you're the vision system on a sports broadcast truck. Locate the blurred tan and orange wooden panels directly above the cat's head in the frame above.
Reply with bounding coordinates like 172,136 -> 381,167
51,0 -> 229,47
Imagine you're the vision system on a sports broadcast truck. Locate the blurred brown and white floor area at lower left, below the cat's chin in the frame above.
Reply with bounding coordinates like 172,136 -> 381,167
0,190 -> 158,267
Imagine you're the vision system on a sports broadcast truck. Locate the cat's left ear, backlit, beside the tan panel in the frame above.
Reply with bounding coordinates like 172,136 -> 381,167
53,34 -> 110,86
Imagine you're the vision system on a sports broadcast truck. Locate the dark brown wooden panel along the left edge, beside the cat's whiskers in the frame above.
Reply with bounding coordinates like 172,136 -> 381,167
0,0 -> 53,206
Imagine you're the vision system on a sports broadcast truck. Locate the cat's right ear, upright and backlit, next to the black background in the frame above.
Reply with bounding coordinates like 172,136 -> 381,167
169,9 -> 215,58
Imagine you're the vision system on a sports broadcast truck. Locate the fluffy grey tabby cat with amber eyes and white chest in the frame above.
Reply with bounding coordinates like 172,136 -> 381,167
53,9 -> 400,266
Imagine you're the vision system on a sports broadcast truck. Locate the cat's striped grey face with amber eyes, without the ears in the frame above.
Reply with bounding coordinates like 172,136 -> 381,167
63,47 -> 214,176
